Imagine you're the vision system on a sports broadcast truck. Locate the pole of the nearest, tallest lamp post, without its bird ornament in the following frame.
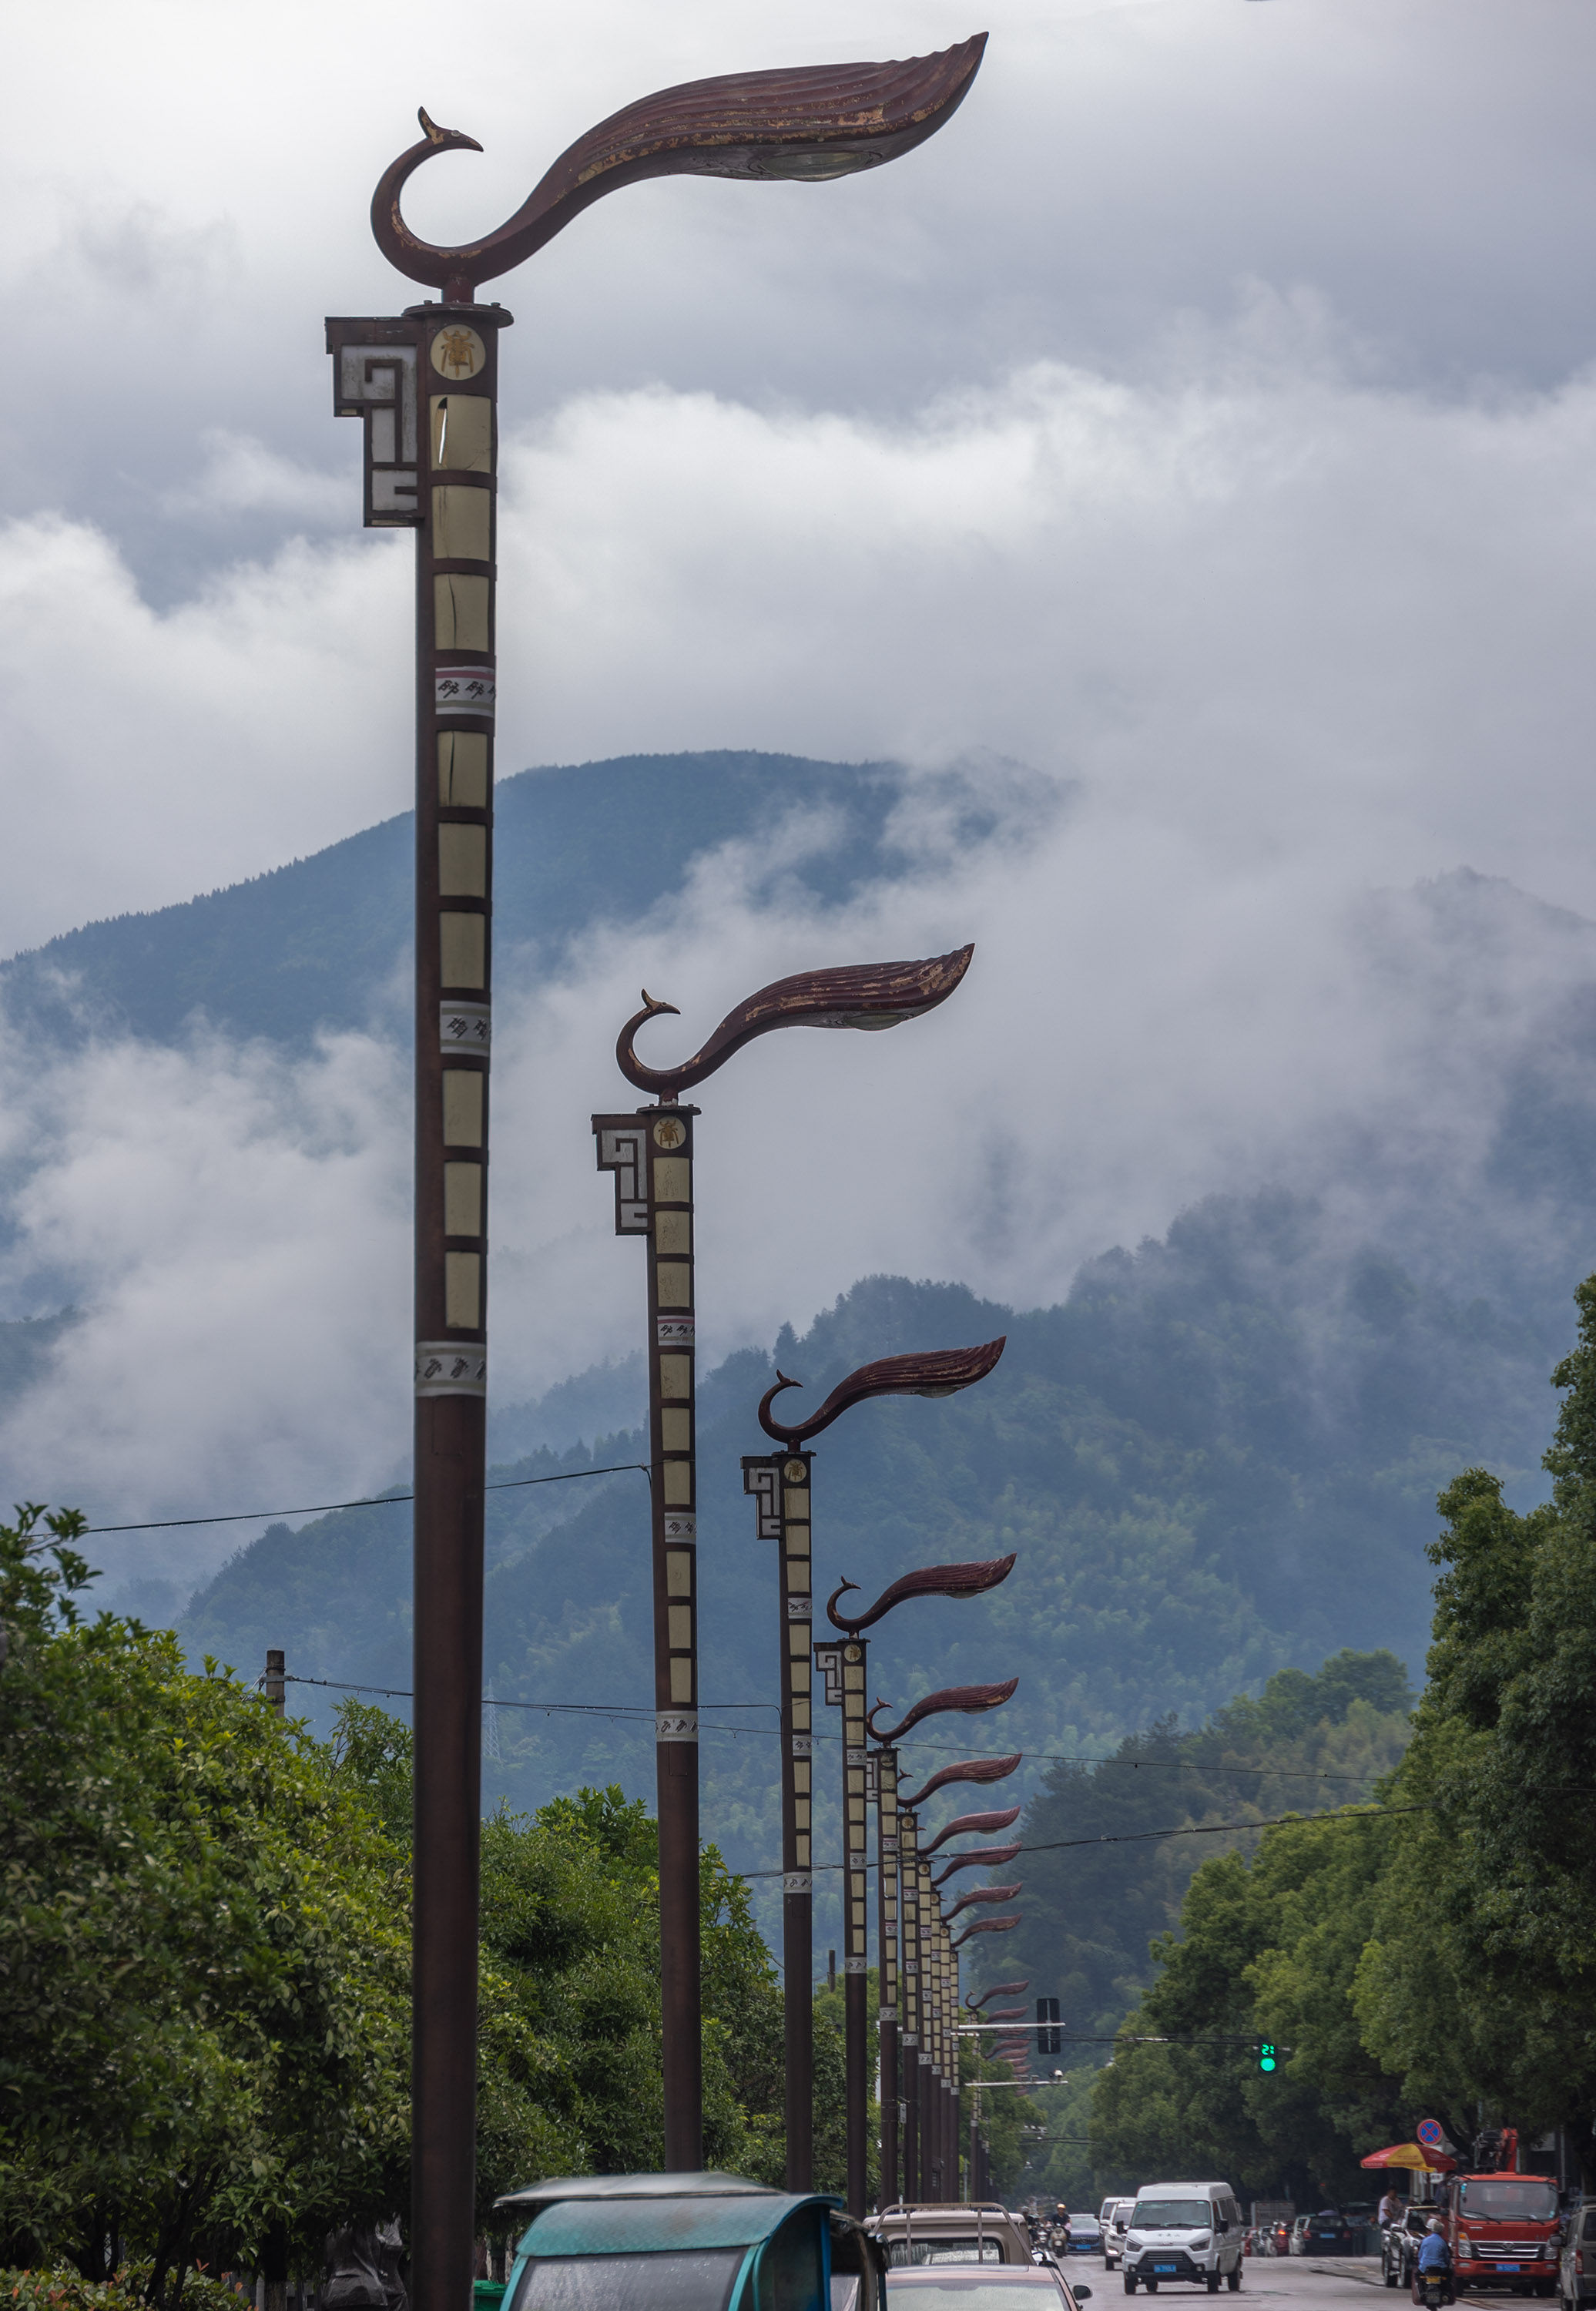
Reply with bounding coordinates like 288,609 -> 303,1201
328,303 -> 511,2311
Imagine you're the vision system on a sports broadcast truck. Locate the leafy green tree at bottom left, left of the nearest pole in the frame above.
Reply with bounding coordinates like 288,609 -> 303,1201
0,1507 -> 409,2306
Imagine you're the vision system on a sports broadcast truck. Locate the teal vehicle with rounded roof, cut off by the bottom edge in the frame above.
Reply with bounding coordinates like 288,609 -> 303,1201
497,2172 -> 887,2311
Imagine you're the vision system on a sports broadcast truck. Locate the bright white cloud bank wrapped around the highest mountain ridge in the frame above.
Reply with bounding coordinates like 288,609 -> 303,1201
0,342 -> 1596,1599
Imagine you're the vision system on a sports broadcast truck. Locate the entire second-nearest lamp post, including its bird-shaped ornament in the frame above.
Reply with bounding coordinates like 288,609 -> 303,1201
594,948 -> 974,2172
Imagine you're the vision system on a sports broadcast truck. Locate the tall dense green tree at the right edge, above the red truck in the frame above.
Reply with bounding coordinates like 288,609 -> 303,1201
1356,1278 -> 1596,2142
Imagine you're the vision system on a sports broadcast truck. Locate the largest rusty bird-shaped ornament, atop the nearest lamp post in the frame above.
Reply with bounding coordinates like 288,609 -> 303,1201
372,32 -> 986,305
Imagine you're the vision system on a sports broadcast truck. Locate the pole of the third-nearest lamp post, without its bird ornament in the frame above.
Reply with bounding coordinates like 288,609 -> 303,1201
744,1451 -> 815,2191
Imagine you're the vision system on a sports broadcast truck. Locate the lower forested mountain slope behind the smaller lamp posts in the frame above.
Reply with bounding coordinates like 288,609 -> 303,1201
180,1195 -> 1552,1950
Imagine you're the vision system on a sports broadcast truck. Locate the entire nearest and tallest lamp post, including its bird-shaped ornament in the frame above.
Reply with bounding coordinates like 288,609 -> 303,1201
328,37 -> 984,2311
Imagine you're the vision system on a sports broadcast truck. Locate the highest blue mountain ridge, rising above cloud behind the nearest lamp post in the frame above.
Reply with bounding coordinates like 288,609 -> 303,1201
0,751 -> 1058,1045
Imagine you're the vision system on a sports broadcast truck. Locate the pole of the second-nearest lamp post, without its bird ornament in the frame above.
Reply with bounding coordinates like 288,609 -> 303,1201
594,1105 -> 705,2172
